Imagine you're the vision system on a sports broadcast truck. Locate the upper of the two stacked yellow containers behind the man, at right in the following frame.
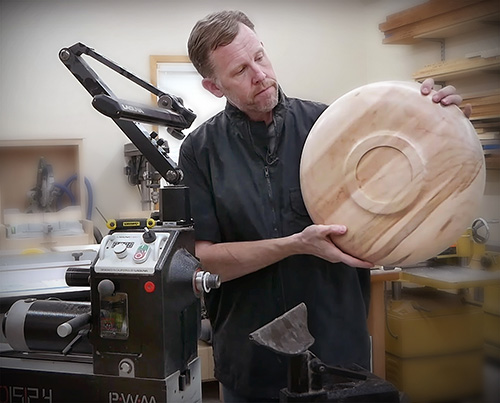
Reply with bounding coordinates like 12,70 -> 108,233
385,288 -> 484,358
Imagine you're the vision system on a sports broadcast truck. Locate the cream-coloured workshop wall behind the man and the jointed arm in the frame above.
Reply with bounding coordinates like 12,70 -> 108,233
0,0 -> 498,246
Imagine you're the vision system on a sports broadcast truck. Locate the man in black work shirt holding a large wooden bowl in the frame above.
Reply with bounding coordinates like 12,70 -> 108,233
179,11 -> 468,402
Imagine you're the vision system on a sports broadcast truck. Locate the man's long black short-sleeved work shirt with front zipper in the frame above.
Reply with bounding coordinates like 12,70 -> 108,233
179,91 -> 369,399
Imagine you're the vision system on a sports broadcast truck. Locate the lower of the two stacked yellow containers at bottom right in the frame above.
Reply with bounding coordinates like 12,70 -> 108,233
386,349 -> 483,403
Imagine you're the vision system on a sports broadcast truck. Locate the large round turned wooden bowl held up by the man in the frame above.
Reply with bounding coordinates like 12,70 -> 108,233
300,82 -> 486,266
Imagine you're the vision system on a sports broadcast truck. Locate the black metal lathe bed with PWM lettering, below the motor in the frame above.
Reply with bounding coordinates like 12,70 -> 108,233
0,348 -> 201,403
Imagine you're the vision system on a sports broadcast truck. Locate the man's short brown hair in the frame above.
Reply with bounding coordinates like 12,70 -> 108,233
188,11 -> 254,78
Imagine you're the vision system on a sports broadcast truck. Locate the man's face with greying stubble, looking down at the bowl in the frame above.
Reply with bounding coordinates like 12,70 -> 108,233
203,24 -> 278,123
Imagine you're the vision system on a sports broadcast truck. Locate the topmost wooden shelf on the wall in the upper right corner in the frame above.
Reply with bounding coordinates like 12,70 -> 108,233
379,0 -> 500,45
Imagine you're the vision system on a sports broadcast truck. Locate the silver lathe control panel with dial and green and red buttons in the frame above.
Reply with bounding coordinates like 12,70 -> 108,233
95,231 -> 170,274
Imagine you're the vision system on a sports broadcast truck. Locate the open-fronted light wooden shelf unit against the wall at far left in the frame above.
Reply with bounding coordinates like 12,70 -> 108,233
0,139 -> 94,250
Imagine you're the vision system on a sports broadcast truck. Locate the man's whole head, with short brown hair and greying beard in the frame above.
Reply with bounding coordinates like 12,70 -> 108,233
188,11 -> 278,123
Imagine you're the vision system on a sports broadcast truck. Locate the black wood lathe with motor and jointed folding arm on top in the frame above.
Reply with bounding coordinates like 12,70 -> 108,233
0,43 -> 220,403
